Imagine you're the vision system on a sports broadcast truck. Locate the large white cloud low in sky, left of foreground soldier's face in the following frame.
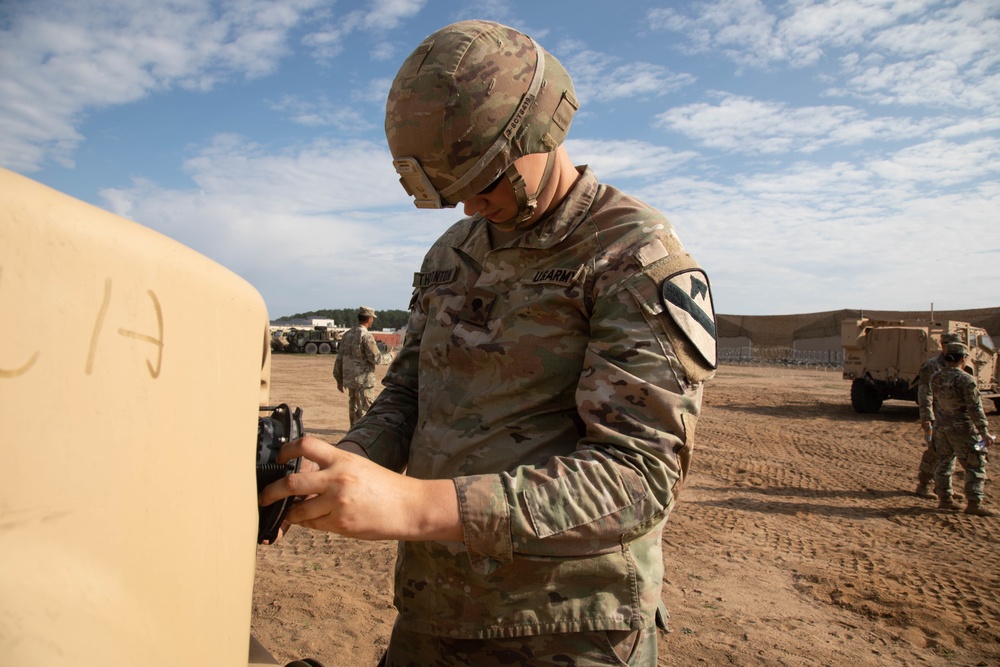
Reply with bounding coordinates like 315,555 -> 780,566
95,135 -> 459,316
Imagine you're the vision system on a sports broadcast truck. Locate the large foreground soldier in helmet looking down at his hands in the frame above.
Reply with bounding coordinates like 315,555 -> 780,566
261,21 -> 717,667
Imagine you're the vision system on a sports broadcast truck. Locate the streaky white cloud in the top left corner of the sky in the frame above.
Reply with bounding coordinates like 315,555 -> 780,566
0,0 -> 326,172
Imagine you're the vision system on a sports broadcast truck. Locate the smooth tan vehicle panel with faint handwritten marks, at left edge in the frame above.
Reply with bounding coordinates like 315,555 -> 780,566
0,170 -> 270,667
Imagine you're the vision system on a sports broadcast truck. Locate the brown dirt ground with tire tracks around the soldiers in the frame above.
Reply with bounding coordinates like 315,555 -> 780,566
252,355 -> 1000,667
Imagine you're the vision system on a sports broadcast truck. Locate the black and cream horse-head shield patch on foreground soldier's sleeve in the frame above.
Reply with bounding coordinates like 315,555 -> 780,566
660,269 -> 719,368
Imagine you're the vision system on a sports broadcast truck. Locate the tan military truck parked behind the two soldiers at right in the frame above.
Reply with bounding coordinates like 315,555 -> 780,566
840,318 -> 1000,414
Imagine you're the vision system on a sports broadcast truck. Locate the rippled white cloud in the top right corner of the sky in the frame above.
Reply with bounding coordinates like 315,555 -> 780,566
648,0 -> 1000,109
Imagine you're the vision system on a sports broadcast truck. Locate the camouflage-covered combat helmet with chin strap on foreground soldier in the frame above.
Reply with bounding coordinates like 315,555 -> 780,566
385,21 -> 579,224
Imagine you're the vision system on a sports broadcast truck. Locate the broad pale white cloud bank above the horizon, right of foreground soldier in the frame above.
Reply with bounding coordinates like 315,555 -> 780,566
629,140 -> 1000,314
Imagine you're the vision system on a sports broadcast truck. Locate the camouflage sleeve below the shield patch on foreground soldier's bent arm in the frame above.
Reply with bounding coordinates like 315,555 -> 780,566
455,260 -> 714,572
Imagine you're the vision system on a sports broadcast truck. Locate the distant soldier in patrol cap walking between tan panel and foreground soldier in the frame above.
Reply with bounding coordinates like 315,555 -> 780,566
333,306 -> 392,426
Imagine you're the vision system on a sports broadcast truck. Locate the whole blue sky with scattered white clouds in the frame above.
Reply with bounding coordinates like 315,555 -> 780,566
0,0 -> 1000,318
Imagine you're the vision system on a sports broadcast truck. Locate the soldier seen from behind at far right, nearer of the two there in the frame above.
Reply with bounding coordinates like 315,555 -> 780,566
931,343 -> 996,516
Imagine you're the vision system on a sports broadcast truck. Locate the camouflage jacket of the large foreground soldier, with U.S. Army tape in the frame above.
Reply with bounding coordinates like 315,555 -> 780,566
346,168 -> 716,638
